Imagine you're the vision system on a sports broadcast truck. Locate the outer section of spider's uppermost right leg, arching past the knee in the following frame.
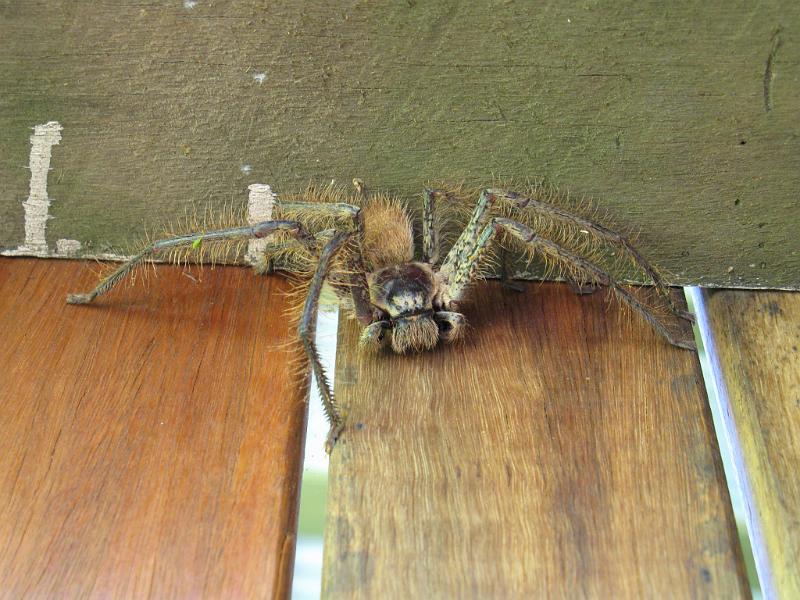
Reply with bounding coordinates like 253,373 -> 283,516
487,189 -> 695,323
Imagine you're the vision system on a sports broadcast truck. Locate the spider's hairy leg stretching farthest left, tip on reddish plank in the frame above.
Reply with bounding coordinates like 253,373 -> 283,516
67,221 -> 315,304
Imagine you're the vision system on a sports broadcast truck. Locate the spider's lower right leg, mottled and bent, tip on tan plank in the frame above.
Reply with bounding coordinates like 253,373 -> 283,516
450,217 -> 696,350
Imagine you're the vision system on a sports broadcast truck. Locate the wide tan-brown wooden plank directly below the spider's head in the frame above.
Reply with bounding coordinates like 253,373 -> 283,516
323,284 -> 749,598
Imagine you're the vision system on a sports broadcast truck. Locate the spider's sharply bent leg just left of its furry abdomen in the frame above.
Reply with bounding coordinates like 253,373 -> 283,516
278,200 -> 373,325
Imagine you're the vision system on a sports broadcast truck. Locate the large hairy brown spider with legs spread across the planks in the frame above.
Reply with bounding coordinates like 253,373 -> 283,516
67,180 -> 695,451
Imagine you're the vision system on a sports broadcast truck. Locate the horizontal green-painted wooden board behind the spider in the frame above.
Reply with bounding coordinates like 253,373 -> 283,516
0,0 -> 800,288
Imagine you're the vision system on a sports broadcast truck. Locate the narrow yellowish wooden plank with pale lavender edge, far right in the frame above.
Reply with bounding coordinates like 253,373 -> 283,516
696,290 -> 800,598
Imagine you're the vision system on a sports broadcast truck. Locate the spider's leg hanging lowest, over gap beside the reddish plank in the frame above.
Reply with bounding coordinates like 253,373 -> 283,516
297,232 -> 353,454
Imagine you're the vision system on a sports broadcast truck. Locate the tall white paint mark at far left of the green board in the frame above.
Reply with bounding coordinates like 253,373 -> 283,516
11,121 -> 63,256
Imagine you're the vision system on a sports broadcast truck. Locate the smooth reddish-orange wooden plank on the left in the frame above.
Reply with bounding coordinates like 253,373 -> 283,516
0,259 -> 307,598
